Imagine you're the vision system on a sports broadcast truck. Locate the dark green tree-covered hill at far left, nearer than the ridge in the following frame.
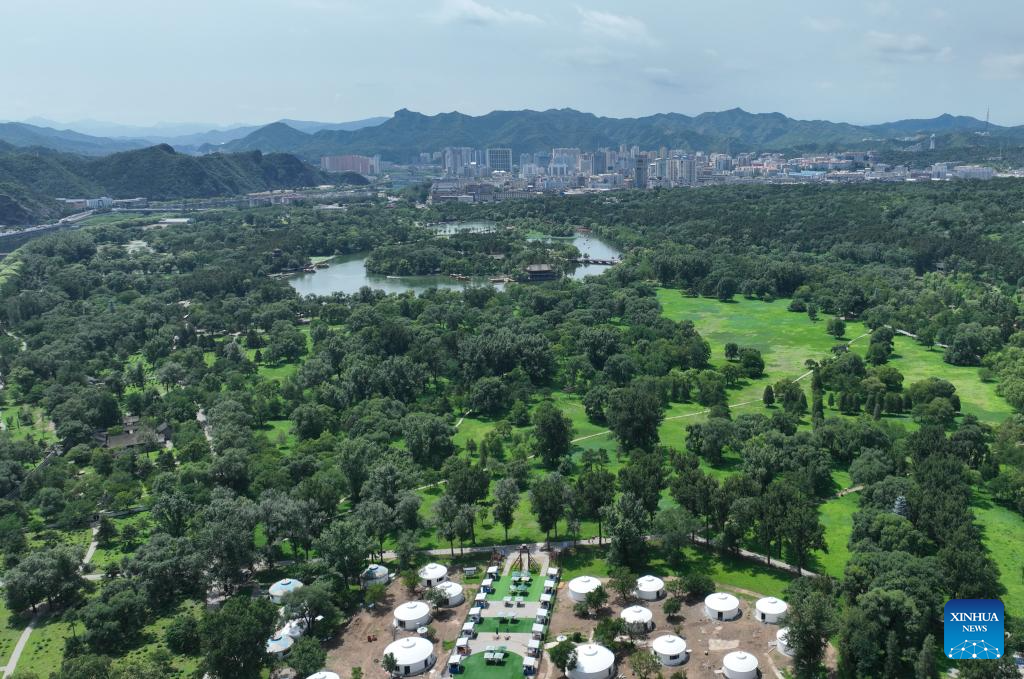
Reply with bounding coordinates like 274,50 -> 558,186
0,144 -> 335,225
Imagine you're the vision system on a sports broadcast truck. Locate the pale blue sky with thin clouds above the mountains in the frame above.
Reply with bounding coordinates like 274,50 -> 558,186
0,0 -> 1024,125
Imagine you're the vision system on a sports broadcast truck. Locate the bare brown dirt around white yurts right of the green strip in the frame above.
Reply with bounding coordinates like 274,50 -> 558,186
543,584 -> 802,679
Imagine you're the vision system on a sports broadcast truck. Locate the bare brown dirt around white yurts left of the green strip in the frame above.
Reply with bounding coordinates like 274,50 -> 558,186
327,572 -> 480,679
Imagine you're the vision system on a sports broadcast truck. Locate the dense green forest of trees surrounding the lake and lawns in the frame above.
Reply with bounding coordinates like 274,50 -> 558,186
0,181 -> 1024,679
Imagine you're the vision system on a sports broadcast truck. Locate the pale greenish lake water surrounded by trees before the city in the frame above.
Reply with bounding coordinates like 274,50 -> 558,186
288,221 -> 621,295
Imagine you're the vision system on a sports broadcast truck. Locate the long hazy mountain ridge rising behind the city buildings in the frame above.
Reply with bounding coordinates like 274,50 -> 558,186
224,109 -> 1024,161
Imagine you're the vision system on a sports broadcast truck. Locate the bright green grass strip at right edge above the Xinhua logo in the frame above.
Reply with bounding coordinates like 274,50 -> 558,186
972,489 -> 1024,611
